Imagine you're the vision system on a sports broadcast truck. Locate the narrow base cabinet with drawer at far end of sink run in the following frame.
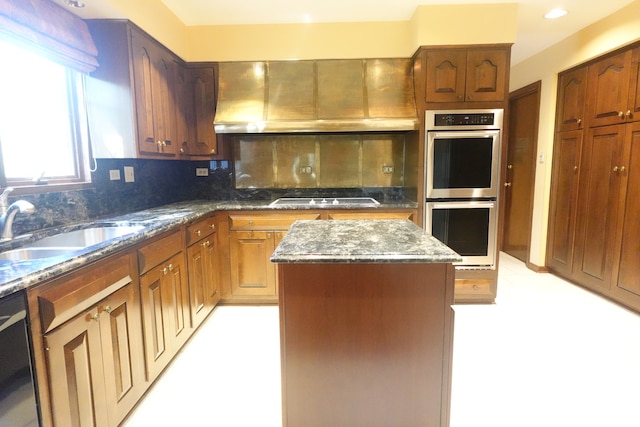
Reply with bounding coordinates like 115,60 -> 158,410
186,215 -> 220,328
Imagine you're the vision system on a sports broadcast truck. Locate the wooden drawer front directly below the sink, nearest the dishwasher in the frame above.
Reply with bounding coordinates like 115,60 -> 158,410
38,255 -> 132,333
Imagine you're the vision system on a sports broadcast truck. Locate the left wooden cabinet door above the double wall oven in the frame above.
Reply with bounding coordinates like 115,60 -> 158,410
425,49 -> 467,102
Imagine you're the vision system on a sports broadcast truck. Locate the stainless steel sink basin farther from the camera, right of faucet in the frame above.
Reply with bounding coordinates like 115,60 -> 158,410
29,225 -> 144,249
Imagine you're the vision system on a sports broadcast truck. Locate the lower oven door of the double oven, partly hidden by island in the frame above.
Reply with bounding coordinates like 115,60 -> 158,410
425,200 -> 498,268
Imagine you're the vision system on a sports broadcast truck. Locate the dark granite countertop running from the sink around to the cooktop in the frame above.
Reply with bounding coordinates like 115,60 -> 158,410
0,200 -> 417,298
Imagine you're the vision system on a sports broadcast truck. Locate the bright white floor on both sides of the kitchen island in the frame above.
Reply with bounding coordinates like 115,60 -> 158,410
124,254 -> 640,427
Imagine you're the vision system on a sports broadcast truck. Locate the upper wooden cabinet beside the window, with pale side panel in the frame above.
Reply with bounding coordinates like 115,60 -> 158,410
86,20 -> 188,159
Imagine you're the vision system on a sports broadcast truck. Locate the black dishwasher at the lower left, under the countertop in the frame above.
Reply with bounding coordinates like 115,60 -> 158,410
0,292 -> 39,427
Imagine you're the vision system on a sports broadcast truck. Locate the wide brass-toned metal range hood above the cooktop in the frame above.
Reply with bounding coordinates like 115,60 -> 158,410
214,59 -> 418,133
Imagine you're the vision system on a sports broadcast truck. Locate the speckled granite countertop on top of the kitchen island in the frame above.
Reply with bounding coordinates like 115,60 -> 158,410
271,220 -> 462,263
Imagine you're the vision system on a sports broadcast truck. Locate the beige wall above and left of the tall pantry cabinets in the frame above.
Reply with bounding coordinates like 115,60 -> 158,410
510,0 -> 640,266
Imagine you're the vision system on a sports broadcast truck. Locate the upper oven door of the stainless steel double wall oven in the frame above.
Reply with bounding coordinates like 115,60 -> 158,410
425,130 -> 500,199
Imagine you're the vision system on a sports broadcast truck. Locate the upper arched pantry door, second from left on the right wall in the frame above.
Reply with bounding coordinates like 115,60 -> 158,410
588,51 -> 631,126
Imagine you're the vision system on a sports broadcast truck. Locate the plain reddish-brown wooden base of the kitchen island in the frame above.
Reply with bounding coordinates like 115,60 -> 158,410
278,263 -> 454,427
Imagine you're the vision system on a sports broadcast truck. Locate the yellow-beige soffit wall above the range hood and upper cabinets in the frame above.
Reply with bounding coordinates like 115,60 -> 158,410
95,0 -> 517,61
